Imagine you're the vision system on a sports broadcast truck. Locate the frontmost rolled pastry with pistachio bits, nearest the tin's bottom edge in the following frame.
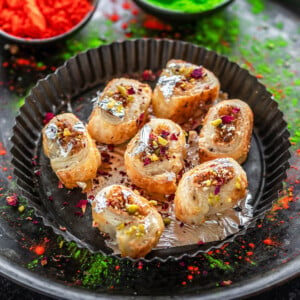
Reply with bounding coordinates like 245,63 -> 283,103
92,185 -> 164,258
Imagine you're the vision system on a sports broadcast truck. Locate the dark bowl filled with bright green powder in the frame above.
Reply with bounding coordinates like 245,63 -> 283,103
133,0 -> 234,22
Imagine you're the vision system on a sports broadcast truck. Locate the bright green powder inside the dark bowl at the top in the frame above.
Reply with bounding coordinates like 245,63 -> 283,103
146,0 -> 227,13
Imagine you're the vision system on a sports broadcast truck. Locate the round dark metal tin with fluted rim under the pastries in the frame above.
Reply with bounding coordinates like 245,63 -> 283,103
12,39 -> 290,260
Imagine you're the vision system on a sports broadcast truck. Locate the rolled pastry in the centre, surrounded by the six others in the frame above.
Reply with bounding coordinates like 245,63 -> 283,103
124,119 -> 186,194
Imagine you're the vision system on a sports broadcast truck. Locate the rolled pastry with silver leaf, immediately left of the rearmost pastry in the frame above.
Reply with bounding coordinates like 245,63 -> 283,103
88,78 -> 152,144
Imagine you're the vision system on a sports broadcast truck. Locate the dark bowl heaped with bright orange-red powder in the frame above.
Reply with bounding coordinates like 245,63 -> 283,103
0,0 -> 98,44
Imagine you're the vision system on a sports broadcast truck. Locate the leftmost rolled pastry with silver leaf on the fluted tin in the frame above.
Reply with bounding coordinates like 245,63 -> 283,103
42,113 -> 101,189
